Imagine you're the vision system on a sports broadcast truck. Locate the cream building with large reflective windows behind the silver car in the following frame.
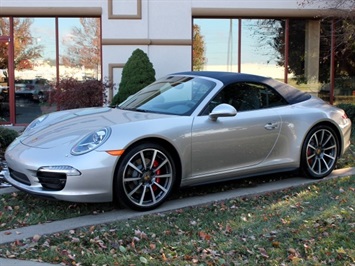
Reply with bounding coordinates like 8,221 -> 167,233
0,0 -> 351,125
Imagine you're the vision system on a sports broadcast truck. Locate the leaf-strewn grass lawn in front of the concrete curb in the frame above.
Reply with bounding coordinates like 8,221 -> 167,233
0,176 -> 355,265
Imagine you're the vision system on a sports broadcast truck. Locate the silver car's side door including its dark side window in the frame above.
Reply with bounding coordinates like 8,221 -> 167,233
192,83 -> 286,178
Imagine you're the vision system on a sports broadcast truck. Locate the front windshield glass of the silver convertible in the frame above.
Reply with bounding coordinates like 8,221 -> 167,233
118,76 -> 216,115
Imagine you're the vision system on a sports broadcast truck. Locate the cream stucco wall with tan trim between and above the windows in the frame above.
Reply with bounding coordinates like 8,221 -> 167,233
0,0 -> 326,92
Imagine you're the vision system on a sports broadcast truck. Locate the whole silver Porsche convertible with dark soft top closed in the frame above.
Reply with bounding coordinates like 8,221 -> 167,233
5,72 -> 351,211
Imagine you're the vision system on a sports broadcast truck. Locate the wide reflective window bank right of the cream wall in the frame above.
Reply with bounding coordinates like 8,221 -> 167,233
193,18 -> 355,103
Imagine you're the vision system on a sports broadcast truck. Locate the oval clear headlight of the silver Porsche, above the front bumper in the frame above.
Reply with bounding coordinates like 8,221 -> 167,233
71,127 -> 111,155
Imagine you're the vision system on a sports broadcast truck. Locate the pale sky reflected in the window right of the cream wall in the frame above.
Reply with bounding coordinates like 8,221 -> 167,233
194,19 -> 283,77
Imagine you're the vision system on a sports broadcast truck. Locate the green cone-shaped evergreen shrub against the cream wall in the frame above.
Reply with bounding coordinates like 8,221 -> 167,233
111,49 -> 155,106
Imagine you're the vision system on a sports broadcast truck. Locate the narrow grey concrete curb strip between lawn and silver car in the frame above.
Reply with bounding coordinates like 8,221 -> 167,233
0,168 -> 355,266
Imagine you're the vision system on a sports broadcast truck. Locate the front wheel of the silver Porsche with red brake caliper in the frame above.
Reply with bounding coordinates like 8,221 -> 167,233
113,143 -> 176,211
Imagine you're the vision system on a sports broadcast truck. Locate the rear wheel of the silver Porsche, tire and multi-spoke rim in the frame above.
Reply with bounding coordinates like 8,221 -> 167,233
301,125 -> 339,179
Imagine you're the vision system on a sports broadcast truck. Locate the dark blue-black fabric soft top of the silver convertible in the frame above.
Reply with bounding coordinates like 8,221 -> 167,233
173,71 -> 312,104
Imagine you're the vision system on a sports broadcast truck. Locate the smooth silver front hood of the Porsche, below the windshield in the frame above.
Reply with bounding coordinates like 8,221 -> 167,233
19,107 -> 174,149
